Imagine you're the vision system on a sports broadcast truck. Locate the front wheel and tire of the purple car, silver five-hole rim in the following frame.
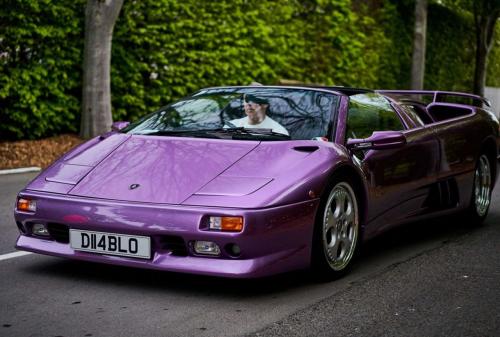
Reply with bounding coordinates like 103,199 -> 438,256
312,179 -> 361,280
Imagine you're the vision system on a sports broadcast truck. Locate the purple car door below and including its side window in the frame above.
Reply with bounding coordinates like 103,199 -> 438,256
346,93 -> 439,234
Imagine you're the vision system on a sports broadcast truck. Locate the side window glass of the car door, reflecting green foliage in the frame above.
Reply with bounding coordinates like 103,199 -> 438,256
346,93 -> 404,138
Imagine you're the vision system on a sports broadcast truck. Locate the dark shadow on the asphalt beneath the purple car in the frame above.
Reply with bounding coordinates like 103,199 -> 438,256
18,214 -> 492,298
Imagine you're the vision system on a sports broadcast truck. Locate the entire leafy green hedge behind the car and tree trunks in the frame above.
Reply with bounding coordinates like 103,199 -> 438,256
0,0 -> 500,139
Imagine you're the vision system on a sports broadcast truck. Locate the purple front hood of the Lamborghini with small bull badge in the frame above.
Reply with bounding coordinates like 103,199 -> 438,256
26,134 -> 347,208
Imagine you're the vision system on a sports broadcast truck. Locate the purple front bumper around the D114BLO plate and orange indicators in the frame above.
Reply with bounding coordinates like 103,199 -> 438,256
15,190 -> 318,278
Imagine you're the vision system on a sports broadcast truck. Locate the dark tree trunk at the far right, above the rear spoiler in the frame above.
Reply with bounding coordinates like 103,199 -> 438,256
474,0 -> 500,96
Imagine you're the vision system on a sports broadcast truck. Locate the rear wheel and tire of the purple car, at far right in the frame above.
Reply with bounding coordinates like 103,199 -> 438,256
466,153 -> 492,225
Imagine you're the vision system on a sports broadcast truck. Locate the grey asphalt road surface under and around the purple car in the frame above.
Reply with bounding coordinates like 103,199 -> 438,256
0,174 -> 500,337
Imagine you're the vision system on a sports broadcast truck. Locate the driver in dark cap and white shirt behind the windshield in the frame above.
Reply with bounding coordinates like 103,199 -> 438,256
231,94 -> 288,135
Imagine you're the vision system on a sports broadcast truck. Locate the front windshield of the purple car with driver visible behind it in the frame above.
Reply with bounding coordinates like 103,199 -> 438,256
123,87 -> 338,140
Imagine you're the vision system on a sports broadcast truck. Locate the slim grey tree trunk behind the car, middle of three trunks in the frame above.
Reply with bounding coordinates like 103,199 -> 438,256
411,0 -> 427,90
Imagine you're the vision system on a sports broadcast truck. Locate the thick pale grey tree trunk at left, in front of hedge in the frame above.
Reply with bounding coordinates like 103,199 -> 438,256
80,0 -> 123,138
